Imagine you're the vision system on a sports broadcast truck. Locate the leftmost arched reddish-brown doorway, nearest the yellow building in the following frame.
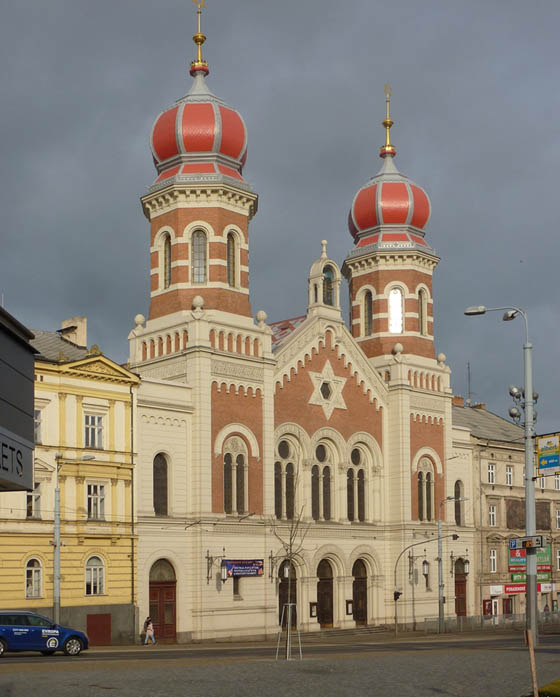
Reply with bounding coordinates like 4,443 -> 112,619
150,559 -> 177,642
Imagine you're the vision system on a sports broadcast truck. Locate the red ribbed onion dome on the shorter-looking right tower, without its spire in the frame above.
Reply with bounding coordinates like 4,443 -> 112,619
348,155 -> 430,247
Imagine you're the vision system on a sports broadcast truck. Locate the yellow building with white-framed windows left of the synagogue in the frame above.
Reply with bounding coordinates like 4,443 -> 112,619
0,317 -> 139,644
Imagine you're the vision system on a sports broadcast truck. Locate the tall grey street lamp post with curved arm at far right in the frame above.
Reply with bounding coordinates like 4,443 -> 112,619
465,305 -> 538,646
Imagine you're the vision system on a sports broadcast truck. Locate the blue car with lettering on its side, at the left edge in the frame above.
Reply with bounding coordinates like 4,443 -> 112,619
0,610 -> 88,656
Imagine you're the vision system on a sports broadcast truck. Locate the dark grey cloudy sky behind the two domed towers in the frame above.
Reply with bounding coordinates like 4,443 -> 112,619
0,0 -> 560,432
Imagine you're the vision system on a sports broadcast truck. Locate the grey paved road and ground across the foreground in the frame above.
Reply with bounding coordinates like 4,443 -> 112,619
0,635 -> 560,697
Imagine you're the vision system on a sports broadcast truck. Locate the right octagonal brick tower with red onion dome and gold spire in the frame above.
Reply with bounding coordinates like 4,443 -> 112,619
342,85 -> 439,359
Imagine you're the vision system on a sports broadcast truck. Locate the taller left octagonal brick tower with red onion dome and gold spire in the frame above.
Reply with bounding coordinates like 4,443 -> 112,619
141,0 -> 257,320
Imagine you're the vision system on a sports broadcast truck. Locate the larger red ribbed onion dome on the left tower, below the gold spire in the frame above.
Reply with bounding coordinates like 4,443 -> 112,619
150,68 -> 247,184
